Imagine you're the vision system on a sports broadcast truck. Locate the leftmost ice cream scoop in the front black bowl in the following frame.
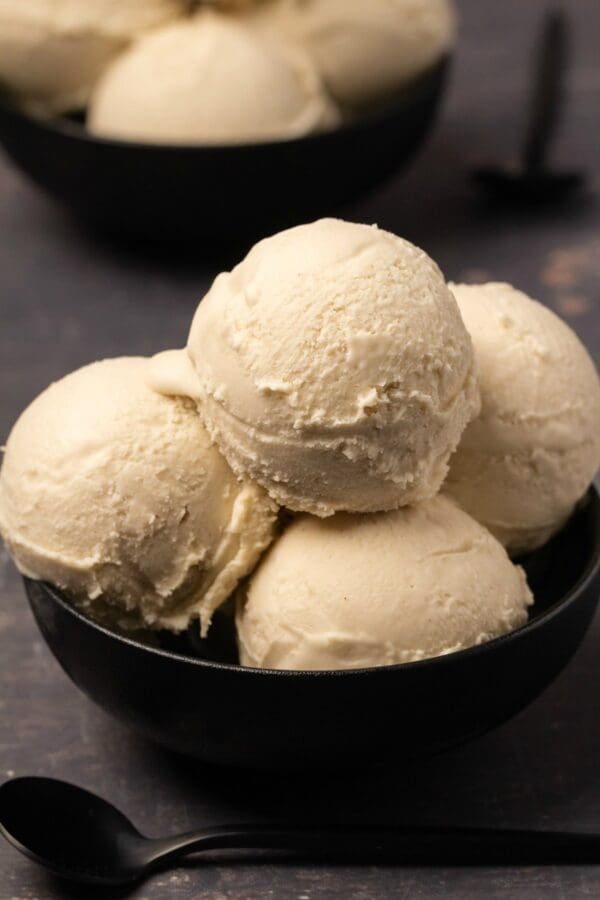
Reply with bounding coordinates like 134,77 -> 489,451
0,358 -> 275,631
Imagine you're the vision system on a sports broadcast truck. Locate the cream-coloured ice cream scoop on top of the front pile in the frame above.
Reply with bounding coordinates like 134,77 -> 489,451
182,219 -> 479,516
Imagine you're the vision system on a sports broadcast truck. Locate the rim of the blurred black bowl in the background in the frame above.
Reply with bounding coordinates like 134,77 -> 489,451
0,57 -> 453,154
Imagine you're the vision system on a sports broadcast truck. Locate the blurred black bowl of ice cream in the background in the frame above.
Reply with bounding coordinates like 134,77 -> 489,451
0,59 -> 448,240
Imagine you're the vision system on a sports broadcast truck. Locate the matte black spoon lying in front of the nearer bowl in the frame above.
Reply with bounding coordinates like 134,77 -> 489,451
0,778 -> 600,885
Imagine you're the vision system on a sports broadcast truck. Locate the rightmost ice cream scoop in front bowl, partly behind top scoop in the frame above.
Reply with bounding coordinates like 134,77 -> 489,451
444,284 -> 600,555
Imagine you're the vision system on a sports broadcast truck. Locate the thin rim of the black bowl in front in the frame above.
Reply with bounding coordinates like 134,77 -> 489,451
25,484 -> 600,679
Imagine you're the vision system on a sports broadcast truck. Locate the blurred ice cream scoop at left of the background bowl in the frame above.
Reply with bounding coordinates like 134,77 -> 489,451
0,0 -> 186,112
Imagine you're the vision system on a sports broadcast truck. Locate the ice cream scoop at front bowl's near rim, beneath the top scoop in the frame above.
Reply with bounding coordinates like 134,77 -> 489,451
237,495 -> 533,669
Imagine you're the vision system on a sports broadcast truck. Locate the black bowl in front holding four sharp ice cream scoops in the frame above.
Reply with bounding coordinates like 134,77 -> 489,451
25,488 -> 600,769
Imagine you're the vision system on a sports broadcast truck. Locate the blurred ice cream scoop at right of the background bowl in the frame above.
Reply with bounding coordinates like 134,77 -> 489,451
246,0 -> 456,107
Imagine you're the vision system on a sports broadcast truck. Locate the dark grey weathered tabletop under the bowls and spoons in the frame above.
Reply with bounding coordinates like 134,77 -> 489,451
0,0 -> 600,900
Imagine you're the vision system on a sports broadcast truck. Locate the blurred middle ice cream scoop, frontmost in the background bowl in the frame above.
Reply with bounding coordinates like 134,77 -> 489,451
88,11 -> 338,144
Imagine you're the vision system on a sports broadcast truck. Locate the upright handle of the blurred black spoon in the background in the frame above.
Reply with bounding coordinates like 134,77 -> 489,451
523,11 -> 568,169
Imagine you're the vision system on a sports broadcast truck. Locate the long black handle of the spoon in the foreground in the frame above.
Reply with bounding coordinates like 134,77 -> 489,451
149,825 -> 600,865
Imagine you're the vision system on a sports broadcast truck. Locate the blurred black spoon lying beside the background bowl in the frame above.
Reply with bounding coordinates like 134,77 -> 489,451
473,11 -> 584,202
